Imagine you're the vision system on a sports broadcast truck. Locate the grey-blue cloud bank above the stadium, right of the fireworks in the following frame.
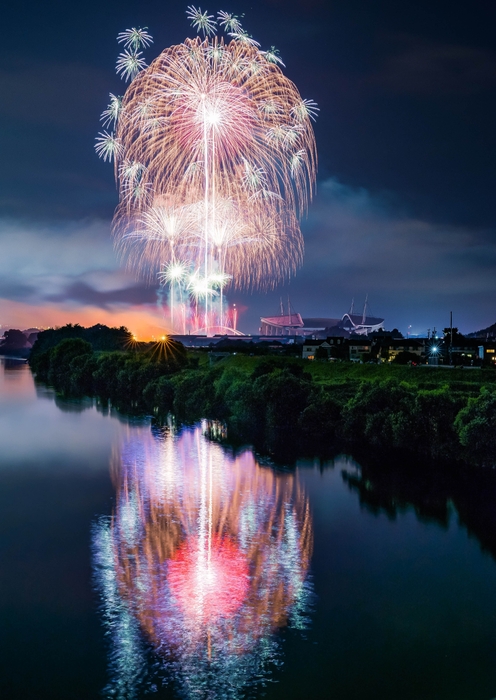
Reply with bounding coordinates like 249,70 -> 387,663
234,179 -> 496,332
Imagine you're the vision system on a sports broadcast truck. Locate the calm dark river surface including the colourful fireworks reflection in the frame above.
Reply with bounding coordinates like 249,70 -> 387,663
0,361 -> 496,700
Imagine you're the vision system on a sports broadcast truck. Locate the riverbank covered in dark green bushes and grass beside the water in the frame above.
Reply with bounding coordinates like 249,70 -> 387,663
30,332 -> 496,467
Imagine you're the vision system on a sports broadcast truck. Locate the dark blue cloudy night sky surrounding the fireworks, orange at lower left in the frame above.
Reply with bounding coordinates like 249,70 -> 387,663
0,0 -> 496,335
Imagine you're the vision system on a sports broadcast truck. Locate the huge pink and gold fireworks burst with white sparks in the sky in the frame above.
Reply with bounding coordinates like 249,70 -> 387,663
96,7 -> 317,334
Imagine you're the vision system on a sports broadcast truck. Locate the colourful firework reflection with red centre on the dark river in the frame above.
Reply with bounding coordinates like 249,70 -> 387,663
94,424 -> 312,698
